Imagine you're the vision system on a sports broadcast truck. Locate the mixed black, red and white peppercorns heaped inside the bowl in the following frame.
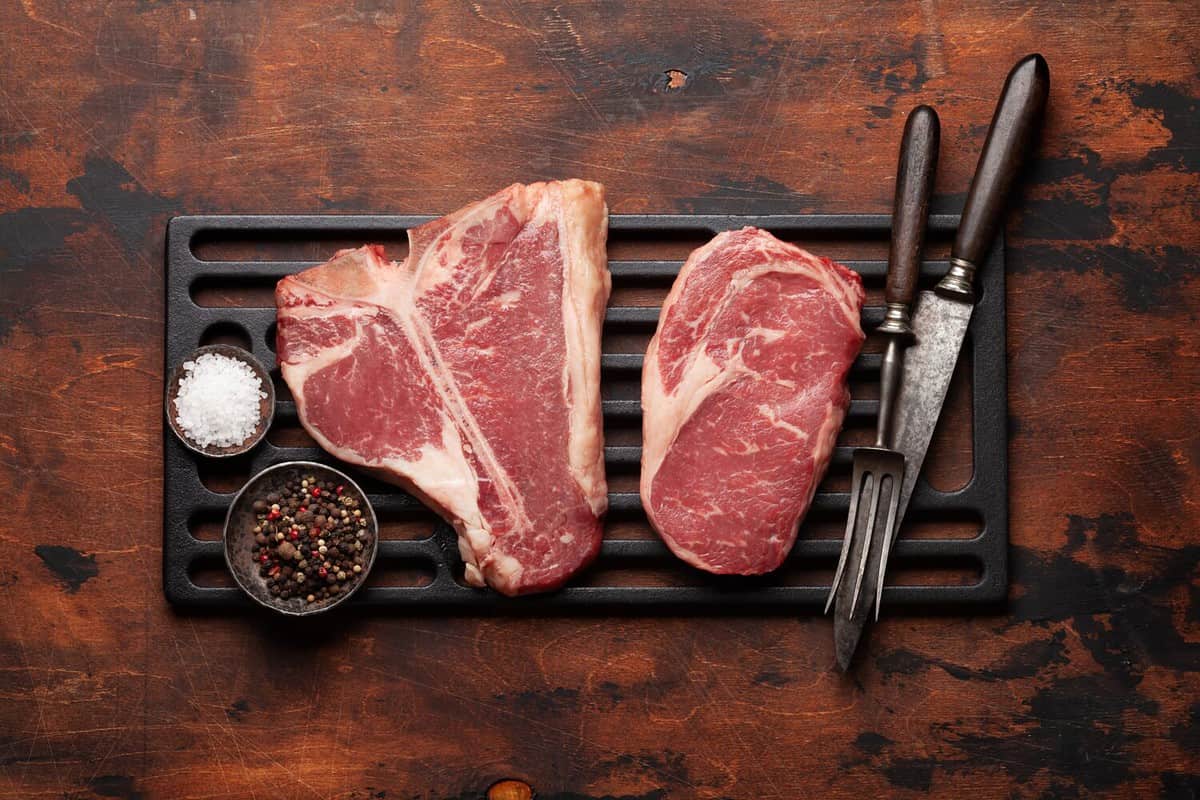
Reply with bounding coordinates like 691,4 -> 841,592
251,475 -> 371,603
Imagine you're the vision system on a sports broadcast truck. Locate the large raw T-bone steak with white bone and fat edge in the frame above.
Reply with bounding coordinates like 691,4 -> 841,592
276,180 -> 611,595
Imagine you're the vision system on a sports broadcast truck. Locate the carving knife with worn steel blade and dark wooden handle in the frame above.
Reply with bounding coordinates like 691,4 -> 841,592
835,54 -> 1050,662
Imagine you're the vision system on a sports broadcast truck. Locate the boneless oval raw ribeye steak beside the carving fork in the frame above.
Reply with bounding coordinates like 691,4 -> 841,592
642,228 -> 864,575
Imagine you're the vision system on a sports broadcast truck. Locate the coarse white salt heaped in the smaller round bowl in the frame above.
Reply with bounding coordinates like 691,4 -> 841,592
175,353 -> 266,447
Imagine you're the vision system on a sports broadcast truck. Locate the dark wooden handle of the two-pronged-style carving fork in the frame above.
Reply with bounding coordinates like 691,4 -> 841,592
884,106 -> 941,306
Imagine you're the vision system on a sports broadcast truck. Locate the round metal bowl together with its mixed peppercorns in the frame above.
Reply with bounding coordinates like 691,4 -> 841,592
224,461 -> 379,616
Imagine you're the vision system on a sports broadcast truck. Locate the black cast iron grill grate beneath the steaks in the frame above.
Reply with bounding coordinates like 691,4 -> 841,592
163,215 -> 1008,613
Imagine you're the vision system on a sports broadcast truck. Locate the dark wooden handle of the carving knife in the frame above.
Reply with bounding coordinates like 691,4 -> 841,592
950,53 -> 1050,272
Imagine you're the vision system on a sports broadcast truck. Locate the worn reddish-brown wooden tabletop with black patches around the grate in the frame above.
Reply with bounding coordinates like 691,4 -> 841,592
0,0 -> 1200,800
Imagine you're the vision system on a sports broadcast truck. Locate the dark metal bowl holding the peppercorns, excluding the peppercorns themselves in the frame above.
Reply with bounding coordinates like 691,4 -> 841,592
224,461 -> 379,616
